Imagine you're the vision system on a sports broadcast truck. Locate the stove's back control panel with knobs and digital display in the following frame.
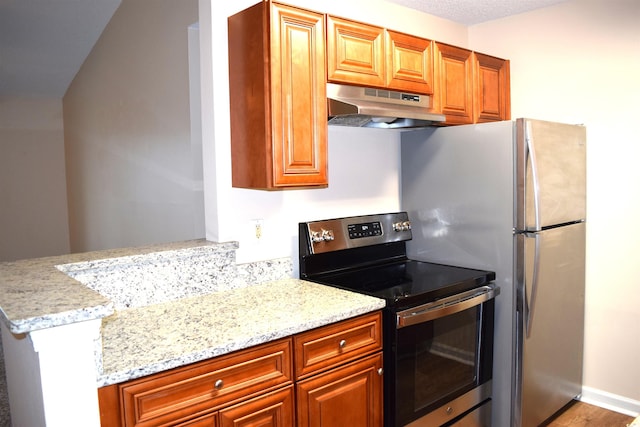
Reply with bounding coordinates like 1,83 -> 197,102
300,212 -> 411,253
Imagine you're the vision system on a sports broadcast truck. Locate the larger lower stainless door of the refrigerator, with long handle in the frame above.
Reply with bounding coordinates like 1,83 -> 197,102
514,223 -> 585,427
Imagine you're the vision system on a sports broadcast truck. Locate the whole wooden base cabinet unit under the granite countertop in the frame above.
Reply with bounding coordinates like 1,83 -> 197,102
98,312 -> 383,427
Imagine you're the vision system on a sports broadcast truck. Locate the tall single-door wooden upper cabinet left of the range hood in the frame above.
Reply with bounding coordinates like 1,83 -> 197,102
228,1 -> 328,189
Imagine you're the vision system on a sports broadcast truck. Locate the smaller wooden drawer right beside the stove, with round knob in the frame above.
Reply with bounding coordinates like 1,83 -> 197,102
294,312 -> 382,379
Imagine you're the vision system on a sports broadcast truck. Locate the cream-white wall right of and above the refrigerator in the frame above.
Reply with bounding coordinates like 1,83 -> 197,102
469,0 -> 640,411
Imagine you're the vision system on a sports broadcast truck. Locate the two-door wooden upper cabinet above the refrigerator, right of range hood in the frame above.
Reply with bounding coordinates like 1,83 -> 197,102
433,42 -> 511,124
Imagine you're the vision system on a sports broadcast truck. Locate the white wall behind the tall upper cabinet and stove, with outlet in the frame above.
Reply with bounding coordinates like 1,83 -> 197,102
205,0 -> 467,262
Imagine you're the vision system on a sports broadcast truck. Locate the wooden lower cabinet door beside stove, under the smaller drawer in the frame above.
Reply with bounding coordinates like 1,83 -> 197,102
297,353 -> 383,427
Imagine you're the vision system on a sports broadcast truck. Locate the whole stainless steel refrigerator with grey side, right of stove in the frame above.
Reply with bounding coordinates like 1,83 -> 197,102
401,119 -> 586,427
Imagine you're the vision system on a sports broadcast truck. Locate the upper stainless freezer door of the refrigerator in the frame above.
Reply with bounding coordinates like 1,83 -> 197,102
516,119 -> 586,231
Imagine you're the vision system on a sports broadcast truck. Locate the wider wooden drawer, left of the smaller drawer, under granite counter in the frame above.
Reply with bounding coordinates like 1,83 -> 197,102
121,339 -> 292,426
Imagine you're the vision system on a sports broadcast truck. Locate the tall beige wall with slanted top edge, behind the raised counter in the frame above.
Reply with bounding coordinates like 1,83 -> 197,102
63,0 -> 204,252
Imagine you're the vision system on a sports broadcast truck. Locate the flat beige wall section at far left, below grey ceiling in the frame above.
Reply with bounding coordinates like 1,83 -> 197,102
0,98 -> 69,261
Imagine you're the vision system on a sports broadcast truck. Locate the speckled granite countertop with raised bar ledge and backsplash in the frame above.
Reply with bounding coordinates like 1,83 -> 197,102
0,240 -> 385,387
